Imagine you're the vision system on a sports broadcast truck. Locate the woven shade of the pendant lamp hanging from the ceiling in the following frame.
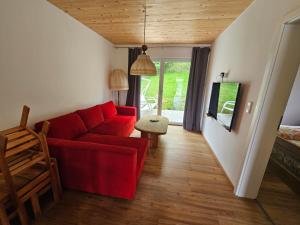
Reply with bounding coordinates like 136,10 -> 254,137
130,54 -> 156,76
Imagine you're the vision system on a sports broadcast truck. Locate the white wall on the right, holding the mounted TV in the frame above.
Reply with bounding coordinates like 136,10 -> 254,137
203,0 -> 300,187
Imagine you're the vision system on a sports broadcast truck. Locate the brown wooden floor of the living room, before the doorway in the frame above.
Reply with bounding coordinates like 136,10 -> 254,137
35,126 -> 270,225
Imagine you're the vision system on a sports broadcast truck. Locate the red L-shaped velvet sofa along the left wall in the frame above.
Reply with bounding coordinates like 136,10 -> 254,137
36,102 -> 148,199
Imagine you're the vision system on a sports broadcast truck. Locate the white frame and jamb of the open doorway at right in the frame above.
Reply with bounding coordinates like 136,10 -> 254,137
235,22 -> 300,199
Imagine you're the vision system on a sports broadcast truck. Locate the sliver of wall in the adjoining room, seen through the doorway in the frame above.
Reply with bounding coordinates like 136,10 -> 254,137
281,68 -> 300,126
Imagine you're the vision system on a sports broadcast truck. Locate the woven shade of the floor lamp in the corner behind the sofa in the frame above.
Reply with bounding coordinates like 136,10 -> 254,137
109,69 -> 129,91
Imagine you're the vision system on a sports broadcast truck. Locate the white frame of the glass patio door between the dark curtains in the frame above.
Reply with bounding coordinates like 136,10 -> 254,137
153,57 -> 192,126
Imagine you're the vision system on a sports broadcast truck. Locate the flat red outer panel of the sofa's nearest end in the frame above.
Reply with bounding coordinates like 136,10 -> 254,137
47,138 -> 137,199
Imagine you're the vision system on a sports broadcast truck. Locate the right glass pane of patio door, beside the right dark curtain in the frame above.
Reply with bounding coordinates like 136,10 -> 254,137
162,61 -> 191,124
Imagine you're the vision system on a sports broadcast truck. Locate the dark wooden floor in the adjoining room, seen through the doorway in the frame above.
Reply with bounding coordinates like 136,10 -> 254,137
257,165 -> 300,225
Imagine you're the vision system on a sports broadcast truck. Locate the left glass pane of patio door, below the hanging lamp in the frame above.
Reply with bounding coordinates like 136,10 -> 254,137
140,61 -> 160,116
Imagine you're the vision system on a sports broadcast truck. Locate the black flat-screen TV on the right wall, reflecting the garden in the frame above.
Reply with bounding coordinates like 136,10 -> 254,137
207,82 -> 241,131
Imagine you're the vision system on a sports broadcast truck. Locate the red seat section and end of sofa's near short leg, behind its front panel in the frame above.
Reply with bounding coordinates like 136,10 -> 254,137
76,133 -> 149,177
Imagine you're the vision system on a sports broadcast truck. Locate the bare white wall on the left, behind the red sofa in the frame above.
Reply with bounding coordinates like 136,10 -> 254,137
0,0 -> 114,130
